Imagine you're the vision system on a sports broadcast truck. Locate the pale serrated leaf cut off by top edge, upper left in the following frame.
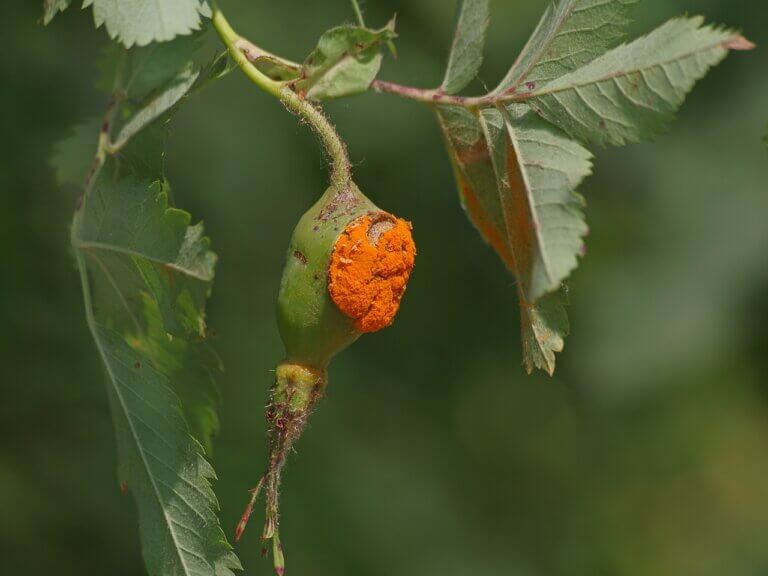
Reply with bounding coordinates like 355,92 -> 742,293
83,0 -> 210,48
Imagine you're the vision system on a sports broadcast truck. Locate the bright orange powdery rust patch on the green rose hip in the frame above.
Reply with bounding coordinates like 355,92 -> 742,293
328,213 -> 416,332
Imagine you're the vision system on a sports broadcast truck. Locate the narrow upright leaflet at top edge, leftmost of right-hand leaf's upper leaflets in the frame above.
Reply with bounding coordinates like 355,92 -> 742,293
440,0 -> 490,94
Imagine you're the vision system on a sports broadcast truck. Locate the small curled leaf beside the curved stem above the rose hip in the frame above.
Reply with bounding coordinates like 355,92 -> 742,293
296,20 -> 395,100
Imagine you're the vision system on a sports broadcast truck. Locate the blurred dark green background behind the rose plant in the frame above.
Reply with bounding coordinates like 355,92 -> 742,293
0,0 -> 768,576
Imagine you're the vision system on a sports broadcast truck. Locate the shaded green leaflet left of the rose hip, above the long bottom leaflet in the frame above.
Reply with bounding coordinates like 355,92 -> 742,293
73,177 -> 216,339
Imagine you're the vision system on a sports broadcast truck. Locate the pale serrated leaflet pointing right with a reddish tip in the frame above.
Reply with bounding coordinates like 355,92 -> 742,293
530,17 -> 752,145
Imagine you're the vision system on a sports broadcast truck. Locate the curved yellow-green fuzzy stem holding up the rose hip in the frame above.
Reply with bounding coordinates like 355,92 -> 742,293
211,3 -> 351,189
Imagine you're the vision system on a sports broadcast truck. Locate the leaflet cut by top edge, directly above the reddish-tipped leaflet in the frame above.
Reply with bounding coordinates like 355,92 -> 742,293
493,0 -> 638,94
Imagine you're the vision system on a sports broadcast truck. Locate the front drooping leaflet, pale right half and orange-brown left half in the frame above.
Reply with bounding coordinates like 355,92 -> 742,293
488,105 -> 592,302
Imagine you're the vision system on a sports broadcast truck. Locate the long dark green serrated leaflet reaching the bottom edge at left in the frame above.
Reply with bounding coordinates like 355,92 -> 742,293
92,323 -> 239,576
